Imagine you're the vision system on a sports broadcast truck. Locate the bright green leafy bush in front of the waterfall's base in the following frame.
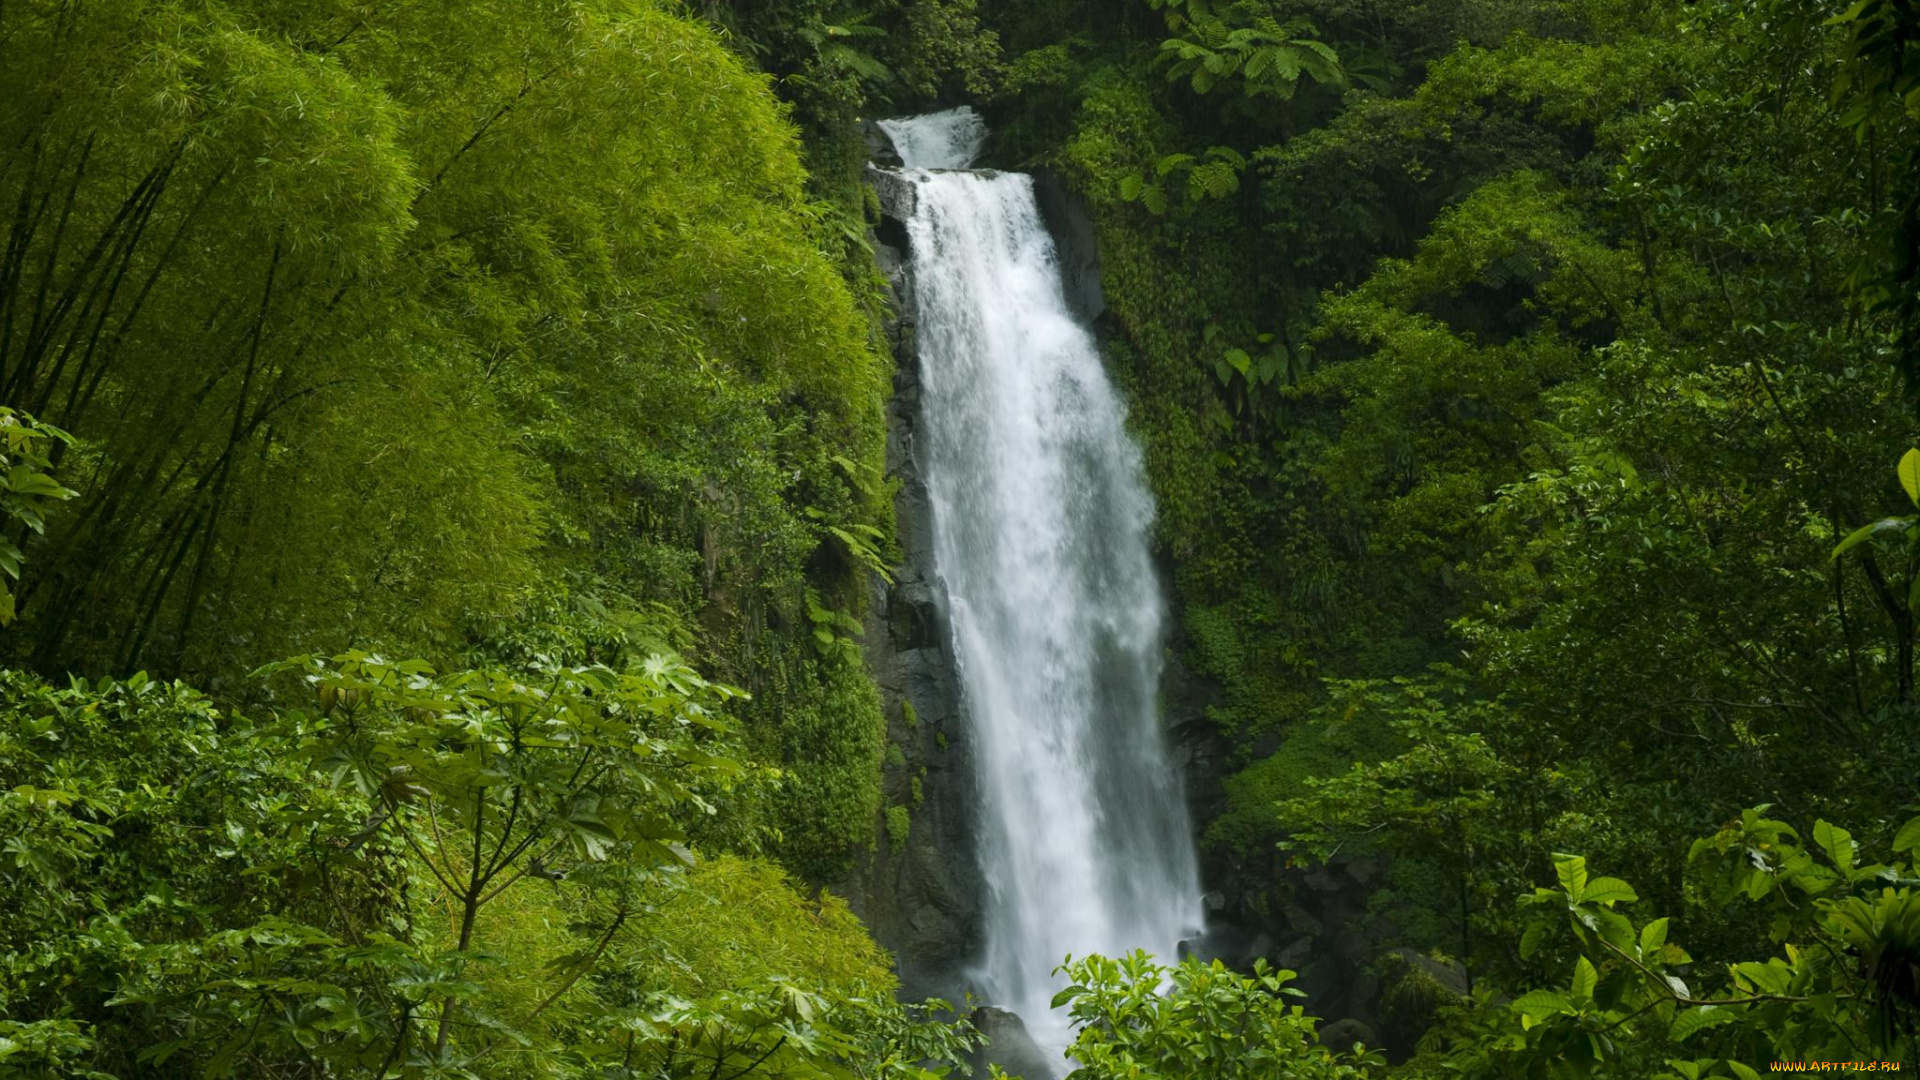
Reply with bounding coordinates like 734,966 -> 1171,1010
1054,953 -> 1382,1080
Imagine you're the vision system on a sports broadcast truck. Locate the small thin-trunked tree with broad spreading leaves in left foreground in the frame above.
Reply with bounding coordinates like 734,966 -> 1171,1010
253,641 -> 743,1055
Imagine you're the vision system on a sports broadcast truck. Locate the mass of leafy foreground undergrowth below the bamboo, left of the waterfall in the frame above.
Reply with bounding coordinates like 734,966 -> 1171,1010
0,655 -> 968,1080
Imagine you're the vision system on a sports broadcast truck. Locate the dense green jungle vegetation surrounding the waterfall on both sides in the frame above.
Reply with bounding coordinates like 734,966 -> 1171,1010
0,0 -> 1920,1080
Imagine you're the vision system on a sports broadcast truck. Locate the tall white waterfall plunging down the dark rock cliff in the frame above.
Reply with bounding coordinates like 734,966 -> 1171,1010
881,110 -> 1202,1060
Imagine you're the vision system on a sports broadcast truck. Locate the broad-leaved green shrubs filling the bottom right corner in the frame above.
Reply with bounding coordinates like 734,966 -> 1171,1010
1446,807 -> 1920,1080
